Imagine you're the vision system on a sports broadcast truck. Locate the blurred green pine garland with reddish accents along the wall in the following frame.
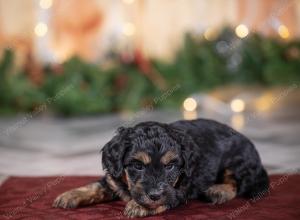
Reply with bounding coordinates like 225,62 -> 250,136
0,28 -> 300,115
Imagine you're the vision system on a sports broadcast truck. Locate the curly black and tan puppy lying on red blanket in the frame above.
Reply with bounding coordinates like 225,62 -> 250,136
53,119 -> 269,217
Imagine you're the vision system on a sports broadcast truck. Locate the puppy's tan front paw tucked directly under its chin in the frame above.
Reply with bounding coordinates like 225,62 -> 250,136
124,200 -> 167,218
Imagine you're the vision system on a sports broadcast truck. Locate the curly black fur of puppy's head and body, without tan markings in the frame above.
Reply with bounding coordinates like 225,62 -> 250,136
102,119 -> 269,212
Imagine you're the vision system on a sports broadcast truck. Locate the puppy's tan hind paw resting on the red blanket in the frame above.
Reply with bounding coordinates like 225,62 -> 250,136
205,184 -> 236,204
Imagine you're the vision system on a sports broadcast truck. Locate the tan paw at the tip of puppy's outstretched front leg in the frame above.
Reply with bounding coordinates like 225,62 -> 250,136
52,190 -> 84,209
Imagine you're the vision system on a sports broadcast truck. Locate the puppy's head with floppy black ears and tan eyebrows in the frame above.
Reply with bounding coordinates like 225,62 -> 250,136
102,122 -> 197,208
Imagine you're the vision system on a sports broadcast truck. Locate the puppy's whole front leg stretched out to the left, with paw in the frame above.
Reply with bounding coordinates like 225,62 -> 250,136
52,179 -> 114,208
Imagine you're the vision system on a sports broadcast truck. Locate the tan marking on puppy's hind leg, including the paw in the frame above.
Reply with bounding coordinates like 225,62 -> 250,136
206,170 -> 237,204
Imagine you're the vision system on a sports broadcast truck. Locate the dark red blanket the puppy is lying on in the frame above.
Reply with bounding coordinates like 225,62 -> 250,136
0,175 -> 300,220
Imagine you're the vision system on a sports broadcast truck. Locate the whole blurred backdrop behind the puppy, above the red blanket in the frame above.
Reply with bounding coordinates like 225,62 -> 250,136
0,0 -> 300,180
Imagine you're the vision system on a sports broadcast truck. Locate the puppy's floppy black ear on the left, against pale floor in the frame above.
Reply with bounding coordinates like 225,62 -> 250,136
101,127 -> 130,178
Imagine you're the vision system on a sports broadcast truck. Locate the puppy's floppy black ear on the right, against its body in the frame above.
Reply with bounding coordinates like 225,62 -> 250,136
169,128 -> 199,177
